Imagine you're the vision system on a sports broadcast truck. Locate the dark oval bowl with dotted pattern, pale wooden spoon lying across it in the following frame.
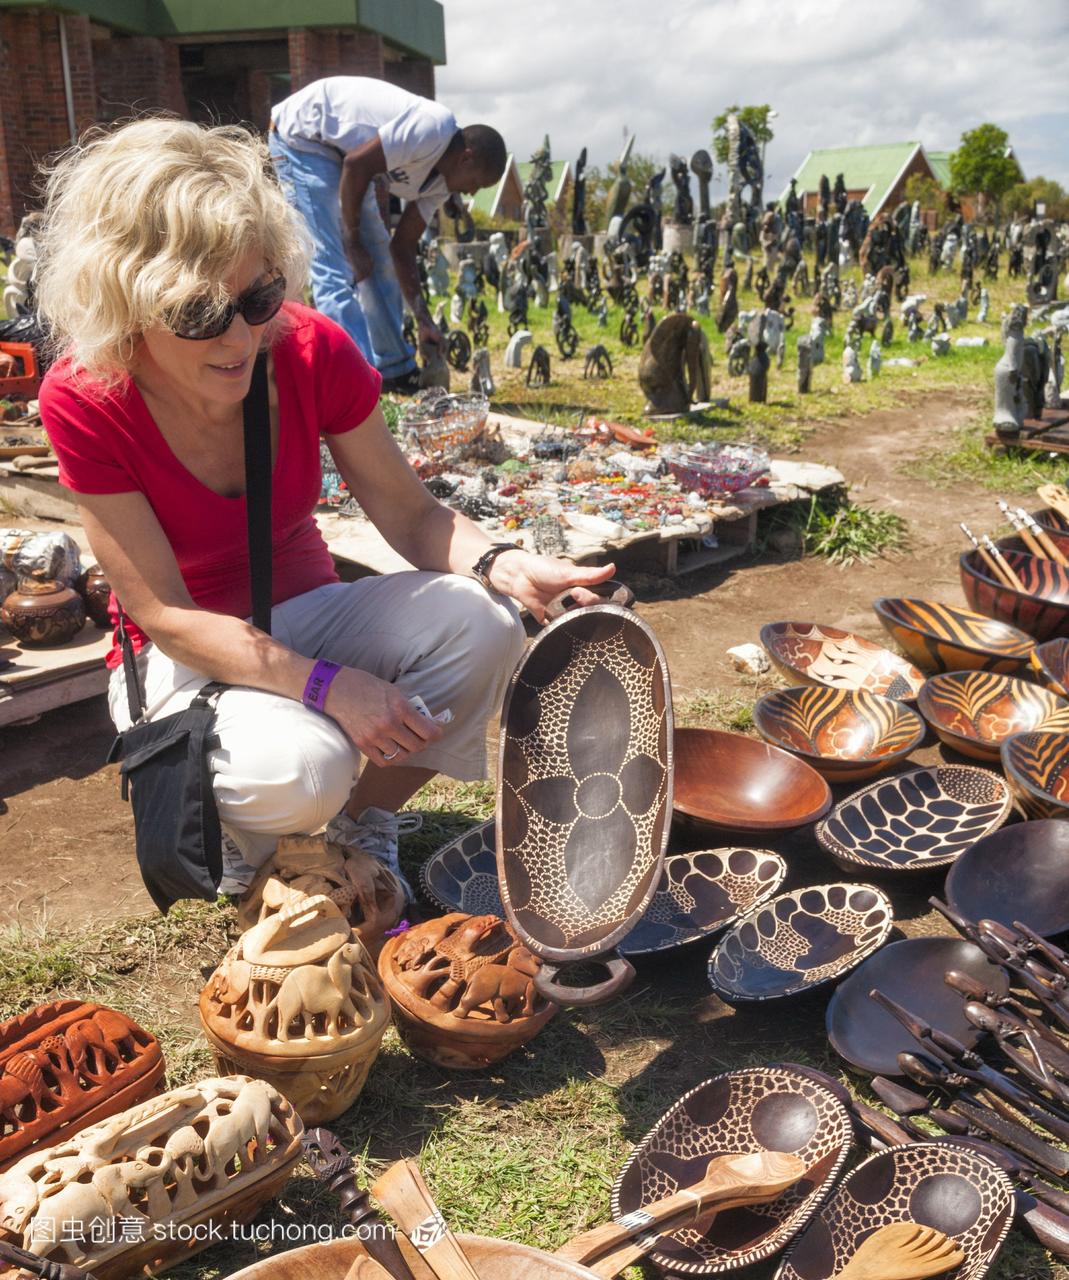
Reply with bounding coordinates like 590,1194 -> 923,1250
612,1065 -> 854,1275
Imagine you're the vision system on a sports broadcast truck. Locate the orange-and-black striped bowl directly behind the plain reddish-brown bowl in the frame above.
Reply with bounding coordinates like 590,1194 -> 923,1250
754,685 -> 926,782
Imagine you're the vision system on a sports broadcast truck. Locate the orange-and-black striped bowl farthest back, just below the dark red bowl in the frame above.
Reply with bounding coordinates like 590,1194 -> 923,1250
872,596 -> 1036,676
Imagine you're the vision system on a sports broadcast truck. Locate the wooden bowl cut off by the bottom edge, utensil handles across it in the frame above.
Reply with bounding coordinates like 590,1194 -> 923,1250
229,1231 -> 597,1280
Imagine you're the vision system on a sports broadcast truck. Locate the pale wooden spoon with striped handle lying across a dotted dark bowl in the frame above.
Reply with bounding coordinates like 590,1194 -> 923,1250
557,1151 -> 805,1276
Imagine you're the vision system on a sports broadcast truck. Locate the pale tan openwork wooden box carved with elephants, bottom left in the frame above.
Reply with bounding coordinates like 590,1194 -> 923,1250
0,1076 -> 303,1280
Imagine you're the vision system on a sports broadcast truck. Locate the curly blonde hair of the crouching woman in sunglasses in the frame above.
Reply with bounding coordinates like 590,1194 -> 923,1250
35,116 -> 309,383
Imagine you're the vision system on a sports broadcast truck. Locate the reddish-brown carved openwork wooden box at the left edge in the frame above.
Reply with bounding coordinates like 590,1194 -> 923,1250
0,1000 -> 164,1169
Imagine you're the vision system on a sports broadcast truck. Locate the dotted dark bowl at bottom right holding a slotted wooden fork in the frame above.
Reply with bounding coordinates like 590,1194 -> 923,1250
775,1142 -> 1014,1280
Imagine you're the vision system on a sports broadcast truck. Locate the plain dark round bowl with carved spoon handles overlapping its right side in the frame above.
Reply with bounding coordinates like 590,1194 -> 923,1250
824,938 -> 1010,1075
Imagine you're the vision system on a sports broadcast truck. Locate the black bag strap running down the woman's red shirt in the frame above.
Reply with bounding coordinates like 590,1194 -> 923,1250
115,352 -> 271,724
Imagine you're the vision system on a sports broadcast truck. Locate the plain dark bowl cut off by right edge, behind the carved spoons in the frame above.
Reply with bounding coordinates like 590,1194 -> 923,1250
946,818 -> 1069,938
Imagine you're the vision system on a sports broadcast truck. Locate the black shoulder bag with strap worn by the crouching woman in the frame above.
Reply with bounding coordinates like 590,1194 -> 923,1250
108,355 -> 271,913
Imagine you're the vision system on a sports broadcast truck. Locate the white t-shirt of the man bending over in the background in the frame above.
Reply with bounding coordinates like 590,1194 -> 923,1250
271,76 -> 458,223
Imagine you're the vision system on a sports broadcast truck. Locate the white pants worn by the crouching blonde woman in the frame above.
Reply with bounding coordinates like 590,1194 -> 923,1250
108,571 -> 524,867
